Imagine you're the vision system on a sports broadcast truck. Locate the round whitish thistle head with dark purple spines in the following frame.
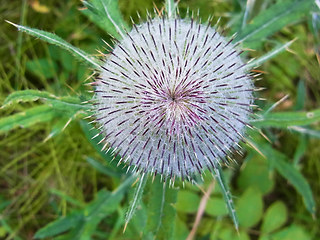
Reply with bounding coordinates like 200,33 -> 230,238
94,14 -> 253,180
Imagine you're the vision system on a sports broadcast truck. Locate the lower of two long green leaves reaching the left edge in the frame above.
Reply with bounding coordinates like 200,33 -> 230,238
0,105 -> 59,133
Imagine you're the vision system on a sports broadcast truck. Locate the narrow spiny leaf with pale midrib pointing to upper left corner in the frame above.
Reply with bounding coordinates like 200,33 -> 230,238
6,21 -> 100,69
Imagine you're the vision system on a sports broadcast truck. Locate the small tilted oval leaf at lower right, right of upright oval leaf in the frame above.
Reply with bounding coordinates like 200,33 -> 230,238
261,201 -> 288,233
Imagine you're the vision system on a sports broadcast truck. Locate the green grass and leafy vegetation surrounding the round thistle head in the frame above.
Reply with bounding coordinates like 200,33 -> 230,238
0,0 -> 320,240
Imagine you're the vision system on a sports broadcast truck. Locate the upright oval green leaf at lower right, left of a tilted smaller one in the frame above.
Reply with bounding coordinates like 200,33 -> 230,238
237,188 -> 263,228
